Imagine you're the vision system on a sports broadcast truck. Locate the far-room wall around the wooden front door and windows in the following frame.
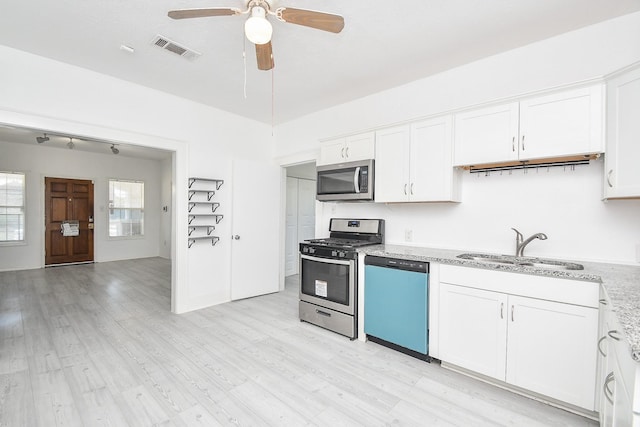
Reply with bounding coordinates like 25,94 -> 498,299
0,141 -> 162,270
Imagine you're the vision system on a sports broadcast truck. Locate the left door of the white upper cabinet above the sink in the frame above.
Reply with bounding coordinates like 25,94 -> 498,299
454,102 -> 519,166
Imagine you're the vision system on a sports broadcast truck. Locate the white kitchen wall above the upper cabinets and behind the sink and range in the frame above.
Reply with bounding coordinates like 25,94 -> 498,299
276,13 -> 640,263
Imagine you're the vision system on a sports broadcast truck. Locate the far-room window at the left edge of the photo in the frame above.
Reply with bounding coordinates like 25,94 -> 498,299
0,172 -> 25,242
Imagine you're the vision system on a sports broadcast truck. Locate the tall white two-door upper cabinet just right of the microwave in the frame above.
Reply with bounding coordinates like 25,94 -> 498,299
375,115 -> 460,203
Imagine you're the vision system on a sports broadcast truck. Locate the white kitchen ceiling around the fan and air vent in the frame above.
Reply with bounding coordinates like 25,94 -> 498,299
0,0 -> 640,158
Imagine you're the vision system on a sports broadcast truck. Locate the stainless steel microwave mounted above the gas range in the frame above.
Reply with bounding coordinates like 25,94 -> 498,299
316,160 -> 374,201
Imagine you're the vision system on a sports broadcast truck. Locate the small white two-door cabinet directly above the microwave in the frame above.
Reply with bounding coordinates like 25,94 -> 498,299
317,132 -> 375,166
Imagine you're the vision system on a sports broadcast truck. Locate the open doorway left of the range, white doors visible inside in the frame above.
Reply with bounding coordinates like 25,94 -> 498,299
285,162 -> 316,277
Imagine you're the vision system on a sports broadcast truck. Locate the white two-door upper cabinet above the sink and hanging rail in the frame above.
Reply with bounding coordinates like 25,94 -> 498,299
454,85 -> 604,166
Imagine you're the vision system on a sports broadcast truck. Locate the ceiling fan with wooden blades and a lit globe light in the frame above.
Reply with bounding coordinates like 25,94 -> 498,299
168,0 -> 344,70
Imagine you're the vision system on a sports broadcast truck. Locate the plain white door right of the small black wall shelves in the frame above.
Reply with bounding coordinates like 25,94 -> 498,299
231,160 -> 280,300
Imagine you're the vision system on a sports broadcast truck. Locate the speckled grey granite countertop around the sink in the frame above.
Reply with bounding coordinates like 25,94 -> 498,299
358,245 -> 640,363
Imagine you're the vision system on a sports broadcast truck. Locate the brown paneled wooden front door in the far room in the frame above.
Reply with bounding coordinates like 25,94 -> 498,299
44,178 -> 93,265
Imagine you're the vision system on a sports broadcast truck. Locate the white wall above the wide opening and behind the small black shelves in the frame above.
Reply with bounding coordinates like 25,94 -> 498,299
0,46 -> 280,312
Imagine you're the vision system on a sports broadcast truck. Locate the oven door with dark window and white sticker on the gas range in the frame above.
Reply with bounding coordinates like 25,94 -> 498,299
301,259 -> 350,306
